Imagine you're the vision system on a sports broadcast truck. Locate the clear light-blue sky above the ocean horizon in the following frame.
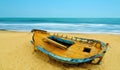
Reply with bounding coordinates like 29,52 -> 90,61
0,0 -> 120,18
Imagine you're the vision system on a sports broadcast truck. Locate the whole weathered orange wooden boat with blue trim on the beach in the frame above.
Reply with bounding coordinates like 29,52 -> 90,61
31,29 -> 108,64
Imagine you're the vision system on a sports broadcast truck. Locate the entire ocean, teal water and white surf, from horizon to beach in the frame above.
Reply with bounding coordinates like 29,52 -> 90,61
0,18 -> 120,34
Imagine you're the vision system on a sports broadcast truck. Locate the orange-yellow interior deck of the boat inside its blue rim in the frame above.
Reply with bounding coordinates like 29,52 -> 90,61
33,31 -> 103,58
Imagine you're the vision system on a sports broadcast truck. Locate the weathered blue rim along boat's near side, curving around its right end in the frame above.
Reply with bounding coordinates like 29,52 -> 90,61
33,38 -> 107,64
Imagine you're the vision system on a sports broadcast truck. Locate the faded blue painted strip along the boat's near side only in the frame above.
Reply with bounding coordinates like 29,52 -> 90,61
36,46 -> 99,64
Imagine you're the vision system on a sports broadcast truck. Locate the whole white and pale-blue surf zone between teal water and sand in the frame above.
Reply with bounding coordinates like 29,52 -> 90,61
0,23 -> 120,33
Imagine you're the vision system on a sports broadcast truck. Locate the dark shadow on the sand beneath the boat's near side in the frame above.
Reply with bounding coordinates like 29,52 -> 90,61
33,51 -> 101,70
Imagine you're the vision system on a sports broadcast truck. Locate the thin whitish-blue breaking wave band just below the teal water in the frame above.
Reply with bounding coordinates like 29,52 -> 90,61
0,23 -> 120,27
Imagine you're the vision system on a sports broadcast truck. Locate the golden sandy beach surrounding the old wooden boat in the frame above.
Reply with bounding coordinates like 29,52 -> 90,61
0,31 -> 120,70
